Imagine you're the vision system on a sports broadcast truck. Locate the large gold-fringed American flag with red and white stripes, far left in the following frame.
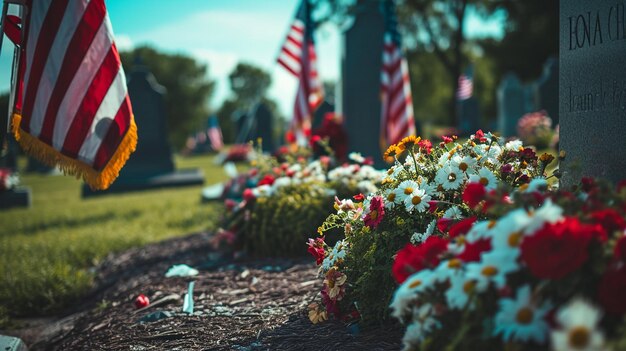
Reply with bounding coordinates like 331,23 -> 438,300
8,0 -> 137,189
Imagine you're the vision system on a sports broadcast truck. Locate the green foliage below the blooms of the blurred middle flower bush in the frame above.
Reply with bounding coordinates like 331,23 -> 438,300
243,184 -> 333,256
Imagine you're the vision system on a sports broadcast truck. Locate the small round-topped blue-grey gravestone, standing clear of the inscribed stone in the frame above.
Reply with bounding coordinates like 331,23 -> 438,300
497,73 -> 528,137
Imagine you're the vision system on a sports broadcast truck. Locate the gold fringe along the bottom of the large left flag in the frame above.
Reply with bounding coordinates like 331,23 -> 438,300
12,112 -> 137,190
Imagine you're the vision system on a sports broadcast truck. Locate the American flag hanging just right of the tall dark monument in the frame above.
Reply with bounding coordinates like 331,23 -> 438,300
380,0 -> 415,148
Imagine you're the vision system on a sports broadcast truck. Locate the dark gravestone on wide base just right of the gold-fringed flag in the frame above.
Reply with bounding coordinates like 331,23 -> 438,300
83,68 -> 204,196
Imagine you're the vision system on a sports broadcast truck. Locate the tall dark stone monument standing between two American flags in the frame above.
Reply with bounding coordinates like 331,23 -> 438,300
341,0 -> 384,166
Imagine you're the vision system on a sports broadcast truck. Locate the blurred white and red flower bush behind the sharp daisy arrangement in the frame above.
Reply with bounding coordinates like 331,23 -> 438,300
214,141 -> 384,256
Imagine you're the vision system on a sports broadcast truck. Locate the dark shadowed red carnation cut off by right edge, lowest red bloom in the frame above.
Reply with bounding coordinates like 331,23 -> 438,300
598,265 -> 626,316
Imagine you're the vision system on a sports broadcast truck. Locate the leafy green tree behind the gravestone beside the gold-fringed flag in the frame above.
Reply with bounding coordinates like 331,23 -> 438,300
120,46 -> 215,149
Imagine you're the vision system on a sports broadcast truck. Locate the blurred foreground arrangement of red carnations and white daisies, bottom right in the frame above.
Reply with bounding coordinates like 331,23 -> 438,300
390,179 -> 626,350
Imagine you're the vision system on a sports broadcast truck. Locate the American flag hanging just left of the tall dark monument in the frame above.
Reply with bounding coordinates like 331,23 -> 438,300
278,0 -> 324,142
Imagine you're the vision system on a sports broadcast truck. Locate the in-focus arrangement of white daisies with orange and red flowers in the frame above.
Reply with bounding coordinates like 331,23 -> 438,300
308,130 -> 553,323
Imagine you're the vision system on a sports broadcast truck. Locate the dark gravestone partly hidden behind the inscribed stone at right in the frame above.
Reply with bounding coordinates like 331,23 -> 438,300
534,58 -> 559,126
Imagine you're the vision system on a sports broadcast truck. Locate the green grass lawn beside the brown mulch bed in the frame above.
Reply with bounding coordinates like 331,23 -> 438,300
0,156 -> 226,325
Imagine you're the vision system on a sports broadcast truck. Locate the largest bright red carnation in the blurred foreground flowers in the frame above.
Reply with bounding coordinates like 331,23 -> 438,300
521,217 -> 603,279
